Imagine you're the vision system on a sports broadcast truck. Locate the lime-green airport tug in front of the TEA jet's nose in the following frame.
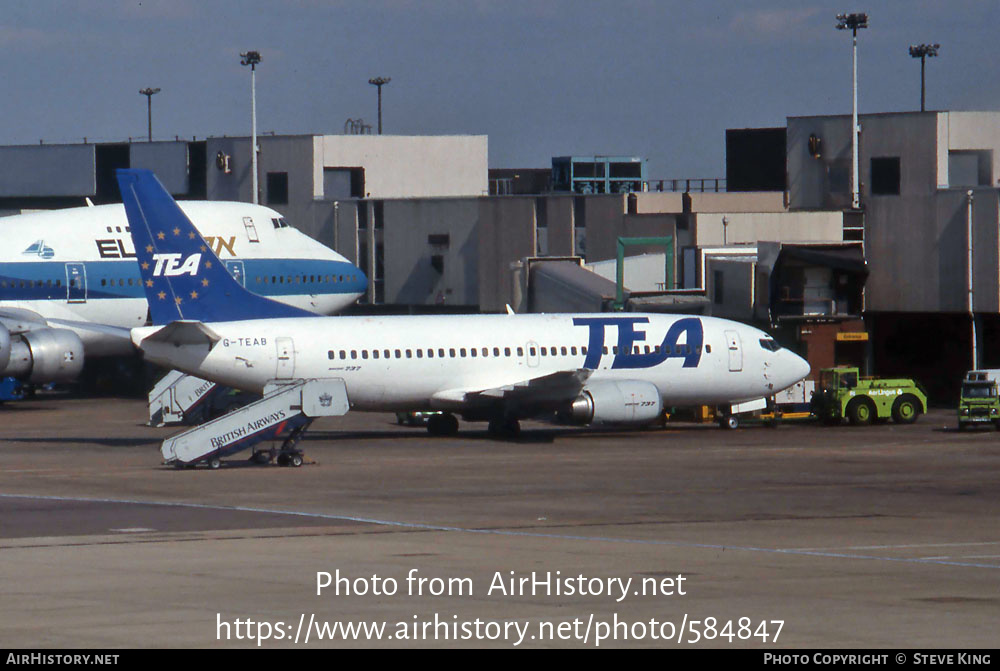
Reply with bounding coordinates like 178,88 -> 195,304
810,366 -> 927,426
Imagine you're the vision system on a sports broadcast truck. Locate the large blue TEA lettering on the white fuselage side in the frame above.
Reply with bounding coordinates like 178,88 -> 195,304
573,317 -> 705,370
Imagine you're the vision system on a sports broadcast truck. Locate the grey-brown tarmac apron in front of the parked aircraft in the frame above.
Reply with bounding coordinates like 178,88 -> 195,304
0,398 -> 1000,650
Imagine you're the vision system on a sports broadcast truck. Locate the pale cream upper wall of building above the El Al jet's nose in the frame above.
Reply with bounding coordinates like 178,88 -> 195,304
312,135 -> 489,199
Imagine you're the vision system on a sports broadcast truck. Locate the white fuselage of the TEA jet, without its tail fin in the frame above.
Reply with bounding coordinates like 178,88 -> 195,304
132,313 -> 809,410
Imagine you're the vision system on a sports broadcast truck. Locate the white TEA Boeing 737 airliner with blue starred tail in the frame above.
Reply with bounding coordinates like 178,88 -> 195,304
118,170 -> 809,435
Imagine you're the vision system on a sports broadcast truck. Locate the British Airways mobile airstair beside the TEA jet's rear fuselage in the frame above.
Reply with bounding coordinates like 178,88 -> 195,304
160,378 -> 350,468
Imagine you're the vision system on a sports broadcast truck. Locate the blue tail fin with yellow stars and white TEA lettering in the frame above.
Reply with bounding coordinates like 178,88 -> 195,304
115,170 -> 316,324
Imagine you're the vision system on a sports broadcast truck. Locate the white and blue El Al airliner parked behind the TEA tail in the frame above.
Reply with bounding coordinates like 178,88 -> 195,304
0,201 -> 367,384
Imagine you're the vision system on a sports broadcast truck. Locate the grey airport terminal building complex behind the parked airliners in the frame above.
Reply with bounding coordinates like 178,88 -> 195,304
0,112 -> 1000,396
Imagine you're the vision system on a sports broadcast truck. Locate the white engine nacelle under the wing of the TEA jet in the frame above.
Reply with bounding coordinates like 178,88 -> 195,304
569,381 -> 663,424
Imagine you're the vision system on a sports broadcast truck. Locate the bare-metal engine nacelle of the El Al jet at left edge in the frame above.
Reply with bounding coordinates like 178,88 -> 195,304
0,324 -> 83,384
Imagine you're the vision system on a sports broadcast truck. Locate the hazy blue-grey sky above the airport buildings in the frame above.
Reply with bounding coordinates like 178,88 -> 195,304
0,0 -> 1000,178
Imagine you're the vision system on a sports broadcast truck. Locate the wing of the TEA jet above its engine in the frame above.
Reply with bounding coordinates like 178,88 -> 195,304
431,368 -> 594,409
